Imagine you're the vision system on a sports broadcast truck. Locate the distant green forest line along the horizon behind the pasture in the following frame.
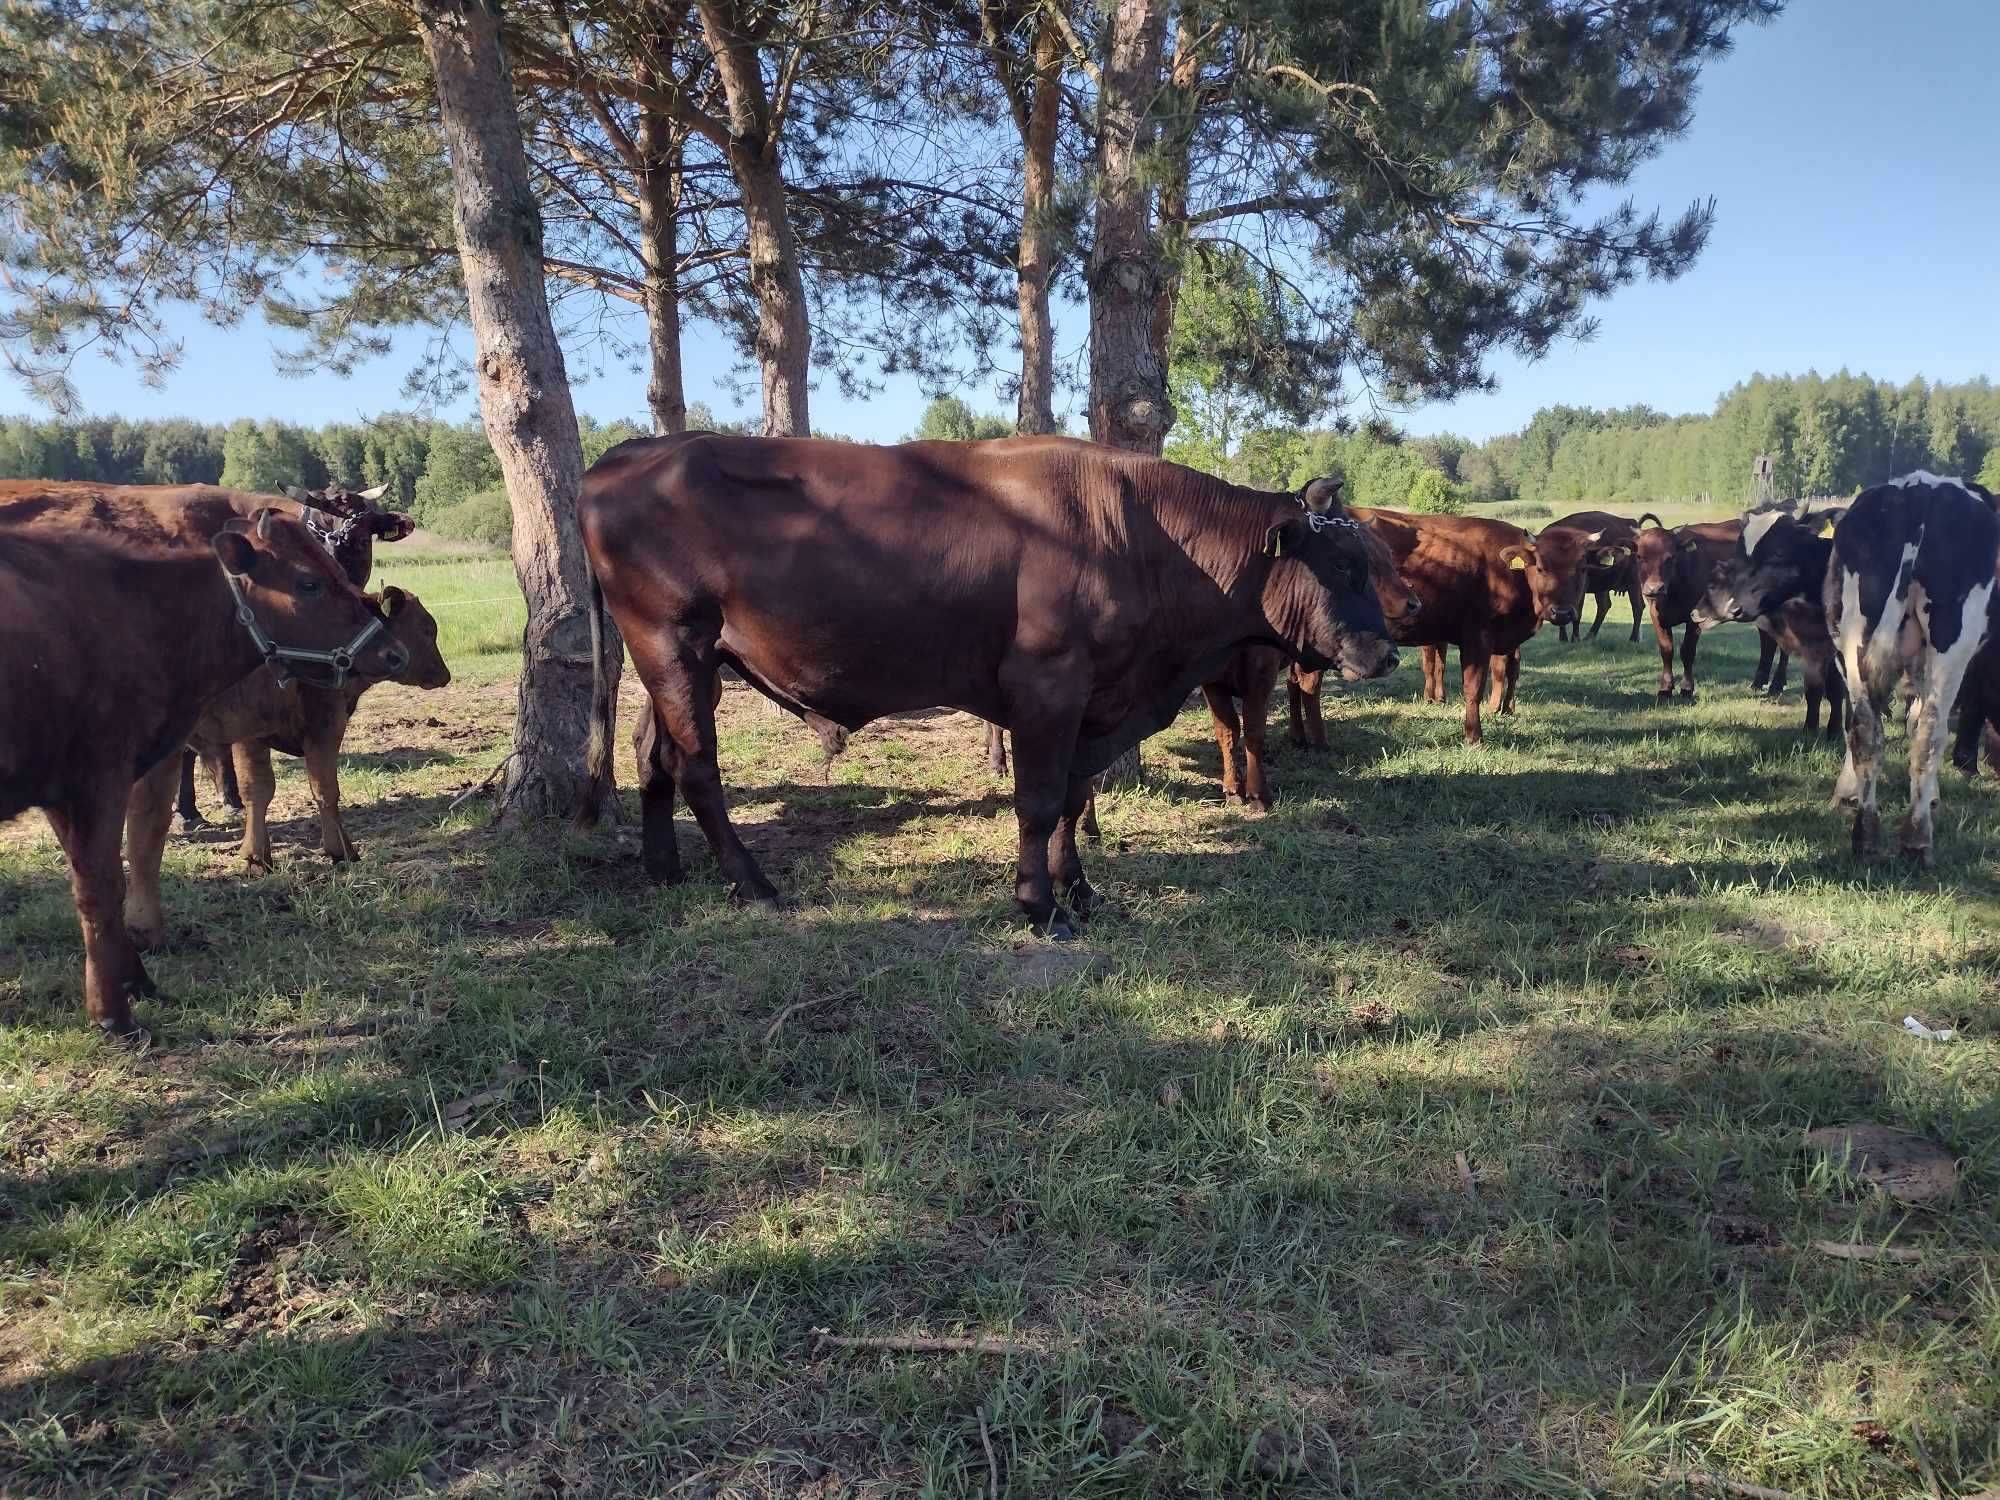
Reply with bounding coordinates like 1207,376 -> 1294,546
0,372 -> 2000,528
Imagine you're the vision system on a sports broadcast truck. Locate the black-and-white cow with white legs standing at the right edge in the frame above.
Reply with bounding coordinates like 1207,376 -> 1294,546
1824,472 -> 2000,866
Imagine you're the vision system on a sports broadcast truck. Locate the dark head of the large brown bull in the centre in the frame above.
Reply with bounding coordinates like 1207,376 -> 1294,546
1264,480 -> 1396,682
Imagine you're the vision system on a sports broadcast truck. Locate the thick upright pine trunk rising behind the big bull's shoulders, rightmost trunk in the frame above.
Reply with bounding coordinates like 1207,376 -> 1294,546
1088,0 -> 1174,786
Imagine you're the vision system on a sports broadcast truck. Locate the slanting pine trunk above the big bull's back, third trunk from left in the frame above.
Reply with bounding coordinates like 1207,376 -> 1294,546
696,0 -> 812,438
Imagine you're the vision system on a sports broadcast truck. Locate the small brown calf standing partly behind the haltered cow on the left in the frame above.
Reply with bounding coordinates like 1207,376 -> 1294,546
158,588 -> 452,870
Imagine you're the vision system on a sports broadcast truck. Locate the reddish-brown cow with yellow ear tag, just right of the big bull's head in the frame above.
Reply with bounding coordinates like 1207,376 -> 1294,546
1352,508 -> 1590,744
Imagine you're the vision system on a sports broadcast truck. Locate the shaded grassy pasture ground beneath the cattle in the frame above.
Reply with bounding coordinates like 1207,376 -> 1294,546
0,548 -> 2000,1500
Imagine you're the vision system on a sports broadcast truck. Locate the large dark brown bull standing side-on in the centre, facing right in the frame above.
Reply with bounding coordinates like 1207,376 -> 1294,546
578,434 -> 1396,936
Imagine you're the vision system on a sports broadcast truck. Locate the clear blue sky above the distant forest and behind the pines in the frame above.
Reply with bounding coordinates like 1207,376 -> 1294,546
19,0 -> 2000,442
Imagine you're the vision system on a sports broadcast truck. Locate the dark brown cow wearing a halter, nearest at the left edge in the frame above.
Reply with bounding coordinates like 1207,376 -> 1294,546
0,512 -> 404,1040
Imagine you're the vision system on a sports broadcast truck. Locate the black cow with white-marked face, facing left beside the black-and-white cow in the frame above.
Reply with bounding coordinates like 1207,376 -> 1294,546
1706,504 -> 1846,740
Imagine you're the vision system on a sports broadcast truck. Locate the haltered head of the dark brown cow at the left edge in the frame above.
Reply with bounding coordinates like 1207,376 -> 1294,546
212,506 -> 410,686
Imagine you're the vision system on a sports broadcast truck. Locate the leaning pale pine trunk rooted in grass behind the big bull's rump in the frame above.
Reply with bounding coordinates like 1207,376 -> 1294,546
418,0 -> 622,820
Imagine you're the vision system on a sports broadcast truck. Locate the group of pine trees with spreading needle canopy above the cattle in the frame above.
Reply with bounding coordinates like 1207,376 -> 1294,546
0,0 -> 1782,812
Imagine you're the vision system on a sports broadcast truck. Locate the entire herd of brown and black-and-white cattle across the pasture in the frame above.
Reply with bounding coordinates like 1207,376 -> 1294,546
0,444 -> 2000,1040
